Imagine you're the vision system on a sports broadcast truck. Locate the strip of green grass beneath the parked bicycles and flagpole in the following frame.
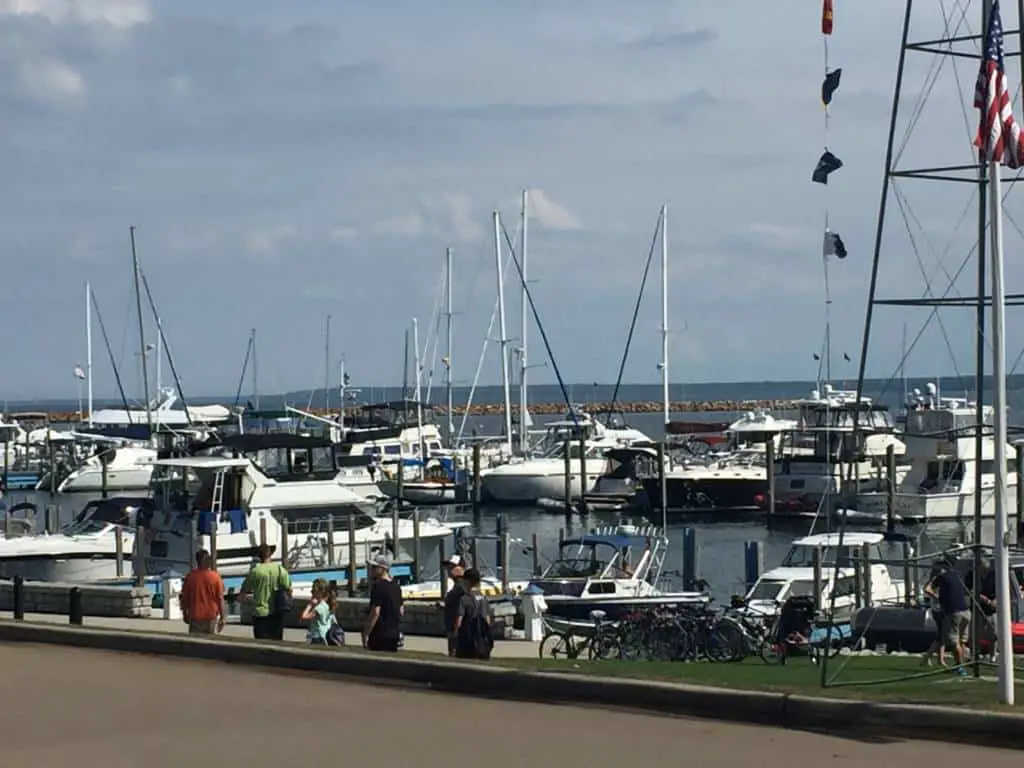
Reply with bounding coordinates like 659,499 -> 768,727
493,656 -> 1024,709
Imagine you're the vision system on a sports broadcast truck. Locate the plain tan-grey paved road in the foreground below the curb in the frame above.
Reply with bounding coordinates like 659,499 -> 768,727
0,644 -> 1018,768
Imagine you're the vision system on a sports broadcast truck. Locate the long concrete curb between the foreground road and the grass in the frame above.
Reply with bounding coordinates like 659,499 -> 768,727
0,621 -> 1024,749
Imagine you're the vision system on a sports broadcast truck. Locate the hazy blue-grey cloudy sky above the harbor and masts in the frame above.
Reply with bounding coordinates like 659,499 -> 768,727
0,0 -> 1024,399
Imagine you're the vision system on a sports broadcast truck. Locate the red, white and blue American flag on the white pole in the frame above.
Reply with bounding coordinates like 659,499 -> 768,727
974,2 -> 1024,168
